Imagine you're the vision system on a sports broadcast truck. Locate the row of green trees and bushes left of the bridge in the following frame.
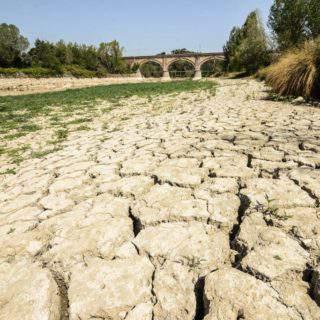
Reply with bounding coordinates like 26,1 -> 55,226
0,23 -> 134,78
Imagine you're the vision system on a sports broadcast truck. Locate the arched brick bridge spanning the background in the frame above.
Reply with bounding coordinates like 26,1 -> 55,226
124,52 -> 224,79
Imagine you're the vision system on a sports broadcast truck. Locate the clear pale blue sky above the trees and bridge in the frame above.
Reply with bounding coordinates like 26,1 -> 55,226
0,0 -> 273,55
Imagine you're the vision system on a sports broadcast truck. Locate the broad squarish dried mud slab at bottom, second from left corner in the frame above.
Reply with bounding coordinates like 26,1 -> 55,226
69,257 -> 154,320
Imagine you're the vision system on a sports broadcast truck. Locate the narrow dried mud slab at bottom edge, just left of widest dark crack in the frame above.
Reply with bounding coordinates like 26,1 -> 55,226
154,262 -> 196,320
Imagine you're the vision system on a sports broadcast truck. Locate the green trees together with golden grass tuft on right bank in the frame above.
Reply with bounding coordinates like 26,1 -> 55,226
224,0 -> 320,99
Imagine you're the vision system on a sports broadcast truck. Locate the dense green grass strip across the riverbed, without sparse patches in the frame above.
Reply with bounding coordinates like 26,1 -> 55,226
0,80 -> 216,132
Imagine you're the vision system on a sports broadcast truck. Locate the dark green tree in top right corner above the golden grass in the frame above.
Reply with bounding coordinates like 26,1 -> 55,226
268,0 -> 310,50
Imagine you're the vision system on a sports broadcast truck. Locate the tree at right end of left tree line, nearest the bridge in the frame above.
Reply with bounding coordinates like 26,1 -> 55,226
98,40 -> 126,73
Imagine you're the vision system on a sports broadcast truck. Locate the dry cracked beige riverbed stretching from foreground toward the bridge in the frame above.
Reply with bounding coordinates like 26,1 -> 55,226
0,80 -> 320,320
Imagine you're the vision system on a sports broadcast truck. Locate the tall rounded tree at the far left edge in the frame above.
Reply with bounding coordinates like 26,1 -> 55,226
0,23 -> 29,67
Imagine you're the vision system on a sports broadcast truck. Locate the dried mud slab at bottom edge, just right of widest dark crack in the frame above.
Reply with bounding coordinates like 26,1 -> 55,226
204,268 -> 301,320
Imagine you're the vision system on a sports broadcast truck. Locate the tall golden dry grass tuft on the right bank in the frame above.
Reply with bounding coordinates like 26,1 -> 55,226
265,38 -> 320,98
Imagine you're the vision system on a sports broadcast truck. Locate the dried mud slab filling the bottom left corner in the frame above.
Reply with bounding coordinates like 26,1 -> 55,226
0,260 -> 63,320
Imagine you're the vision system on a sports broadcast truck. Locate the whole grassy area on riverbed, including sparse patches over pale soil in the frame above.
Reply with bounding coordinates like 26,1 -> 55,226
0,80 -> 216,164
